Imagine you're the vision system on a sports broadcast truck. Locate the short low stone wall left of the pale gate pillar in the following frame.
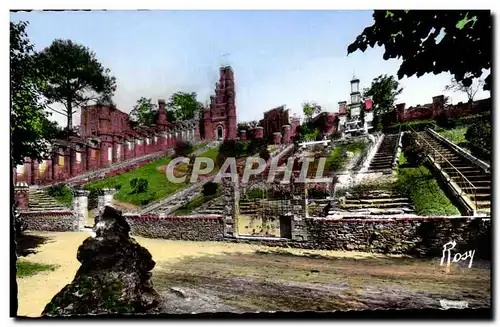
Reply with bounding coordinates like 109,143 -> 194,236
20,210 -> 78,232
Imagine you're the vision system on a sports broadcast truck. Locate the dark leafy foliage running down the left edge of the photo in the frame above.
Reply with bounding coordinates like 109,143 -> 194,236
10,22 -> 48,167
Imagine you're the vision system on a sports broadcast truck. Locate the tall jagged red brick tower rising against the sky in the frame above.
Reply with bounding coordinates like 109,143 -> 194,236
200,66 -> 237,140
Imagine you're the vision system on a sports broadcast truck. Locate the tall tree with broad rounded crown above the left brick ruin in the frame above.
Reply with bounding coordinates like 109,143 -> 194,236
37,39 -> 116,135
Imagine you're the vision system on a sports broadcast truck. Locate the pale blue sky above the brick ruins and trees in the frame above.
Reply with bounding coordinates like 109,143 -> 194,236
10,10 -> 490,126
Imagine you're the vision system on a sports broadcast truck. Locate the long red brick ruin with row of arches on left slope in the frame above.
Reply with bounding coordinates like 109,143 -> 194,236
15,100 -> 200,185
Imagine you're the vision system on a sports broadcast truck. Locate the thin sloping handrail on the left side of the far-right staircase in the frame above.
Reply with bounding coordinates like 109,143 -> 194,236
408,126 -> 477,210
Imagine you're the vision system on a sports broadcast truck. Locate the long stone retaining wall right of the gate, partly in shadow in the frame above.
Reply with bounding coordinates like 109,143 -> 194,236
301,217 -> 492,258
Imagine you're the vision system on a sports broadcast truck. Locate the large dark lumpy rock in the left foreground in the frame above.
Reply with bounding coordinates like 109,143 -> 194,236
42,206 -> 161,316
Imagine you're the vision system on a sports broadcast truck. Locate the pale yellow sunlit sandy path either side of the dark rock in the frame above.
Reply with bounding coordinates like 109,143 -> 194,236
17,232 -> 398,317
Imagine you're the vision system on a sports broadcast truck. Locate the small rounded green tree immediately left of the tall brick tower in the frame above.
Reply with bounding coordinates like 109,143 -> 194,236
166,92 -> 203,122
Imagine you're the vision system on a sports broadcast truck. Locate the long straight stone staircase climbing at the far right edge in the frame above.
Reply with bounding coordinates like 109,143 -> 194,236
418,131 -> 491,215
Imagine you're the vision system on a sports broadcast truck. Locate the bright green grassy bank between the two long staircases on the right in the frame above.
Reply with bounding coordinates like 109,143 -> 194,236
396,153 -> 460,216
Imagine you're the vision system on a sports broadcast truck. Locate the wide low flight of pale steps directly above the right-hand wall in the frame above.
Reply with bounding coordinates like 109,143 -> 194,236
328,190 -> 416,217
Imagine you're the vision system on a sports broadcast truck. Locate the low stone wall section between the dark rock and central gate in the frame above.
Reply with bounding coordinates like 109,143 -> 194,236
124,215 -> 224,241
